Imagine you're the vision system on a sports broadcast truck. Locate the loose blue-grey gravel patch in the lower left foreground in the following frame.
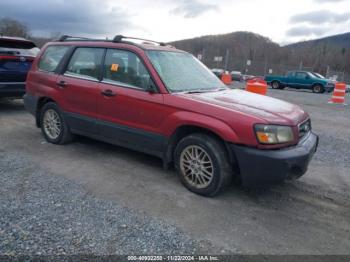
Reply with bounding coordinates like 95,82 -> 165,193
0,151 -> 208,255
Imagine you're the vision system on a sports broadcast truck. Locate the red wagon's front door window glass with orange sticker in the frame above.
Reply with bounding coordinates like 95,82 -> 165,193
103,49 -> 151,90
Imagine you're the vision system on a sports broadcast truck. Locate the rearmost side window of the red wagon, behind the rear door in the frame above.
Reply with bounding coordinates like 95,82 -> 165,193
38,46 -> 69,72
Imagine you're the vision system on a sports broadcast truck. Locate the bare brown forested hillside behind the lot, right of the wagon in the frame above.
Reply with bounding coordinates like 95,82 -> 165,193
171,32 -> 350,80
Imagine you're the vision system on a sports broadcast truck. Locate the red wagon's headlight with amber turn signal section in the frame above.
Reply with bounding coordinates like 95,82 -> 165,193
255,125 -> 294,144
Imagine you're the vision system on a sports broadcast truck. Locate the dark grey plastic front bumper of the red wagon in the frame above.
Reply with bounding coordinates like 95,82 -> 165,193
231,132 -> 318,187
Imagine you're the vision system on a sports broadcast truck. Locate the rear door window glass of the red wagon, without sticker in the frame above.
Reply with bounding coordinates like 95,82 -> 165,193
65,47 -> 104,80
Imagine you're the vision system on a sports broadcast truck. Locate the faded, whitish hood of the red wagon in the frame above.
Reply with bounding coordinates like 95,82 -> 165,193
179,89 -> 308,125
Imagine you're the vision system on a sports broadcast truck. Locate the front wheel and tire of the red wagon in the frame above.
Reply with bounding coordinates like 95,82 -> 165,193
174,133 -> 233,197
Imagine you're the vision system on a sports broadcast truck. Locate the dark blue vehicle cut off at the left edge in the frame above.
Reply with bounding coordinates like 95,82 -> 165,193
0,36 -> 39,98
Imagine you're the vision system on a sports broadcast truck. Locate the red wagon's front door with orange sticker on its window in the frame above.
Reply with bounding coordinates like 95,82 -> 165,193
98,49 -> 166,155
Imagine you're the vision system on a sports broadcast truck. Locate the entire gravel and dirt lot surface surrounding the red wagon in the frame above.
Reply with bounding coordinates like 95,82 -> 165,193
0,89 -> 350,255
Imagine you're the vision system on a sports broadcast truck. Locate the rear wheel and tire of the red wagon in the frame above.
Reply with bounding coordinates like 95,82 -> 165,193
40,102 -> 73,145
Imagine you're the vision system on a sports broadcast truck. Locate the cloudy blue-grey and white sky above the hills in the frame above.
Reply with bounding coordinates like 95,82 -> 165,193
0,0 -> 350,45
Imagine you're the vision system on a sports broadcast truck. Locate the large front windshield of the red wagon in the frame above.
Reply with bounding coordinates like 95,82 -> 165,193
146,51 -> 226,92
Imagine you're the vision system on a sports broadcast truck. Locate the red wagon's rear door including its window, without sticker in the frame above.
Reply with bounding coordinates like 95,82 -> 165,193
57,47 -> 105,135
